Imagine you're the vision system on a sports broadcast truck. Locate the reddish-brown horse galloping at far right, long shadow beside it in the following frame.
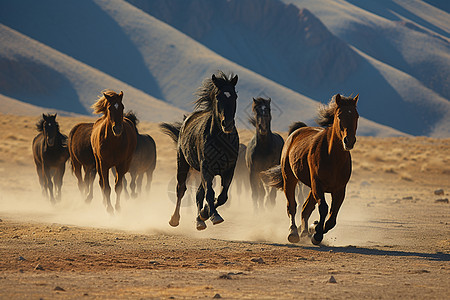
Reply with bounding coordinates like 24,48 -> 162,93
266,94 -> 359,245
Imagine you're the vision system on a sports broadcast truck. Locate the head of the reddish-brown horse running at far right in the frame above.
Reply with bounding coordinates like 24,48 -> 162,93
333,94 -> 359,151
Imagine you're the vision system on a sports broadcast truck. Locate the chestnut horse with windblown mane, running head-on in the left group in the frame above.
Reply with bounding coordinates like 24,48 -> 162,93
91,91 -> 137,213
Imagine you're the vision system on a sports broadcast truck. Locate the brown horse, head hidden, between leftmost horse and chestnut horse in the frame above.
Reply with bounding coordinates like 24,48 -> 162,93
68,123 -> 97,203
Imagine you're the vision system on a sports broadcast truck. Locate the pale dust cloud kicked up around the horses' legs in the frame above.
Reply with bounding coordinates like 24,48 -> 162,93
0,169 -> 380,246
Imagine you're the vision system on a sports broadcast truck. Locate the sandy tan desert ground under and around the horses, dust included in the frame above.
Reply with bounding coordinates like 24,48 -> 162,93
0,114 -> 450,299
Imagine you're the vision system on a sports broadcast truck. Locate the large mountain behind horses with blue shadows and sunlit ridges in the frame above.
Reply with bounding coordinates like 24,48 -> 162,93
0,0 -> 450,136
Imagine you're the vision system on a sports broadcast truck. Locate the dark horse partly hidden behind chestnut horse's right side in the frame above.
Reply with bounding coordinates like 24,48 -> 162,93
123,112 -> 156,198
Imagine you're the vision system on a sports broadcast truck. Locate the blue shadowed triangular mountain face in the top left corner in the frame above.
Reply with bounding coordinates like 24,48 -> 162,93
0,0 -> 161,98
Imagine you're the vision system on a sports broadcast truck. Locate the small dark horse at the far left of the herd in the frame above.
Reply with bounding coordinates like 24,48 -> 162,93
32,114 -> 69,204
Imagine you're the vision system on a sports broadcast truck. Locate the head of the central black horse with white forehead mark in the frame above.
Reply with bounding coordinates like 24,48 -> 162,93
211,74 -> 238,133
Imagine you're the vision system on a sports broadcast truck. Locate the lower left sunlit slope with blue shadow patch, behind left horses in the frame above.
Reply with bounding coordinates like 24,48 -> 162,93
0,25 -> 183,121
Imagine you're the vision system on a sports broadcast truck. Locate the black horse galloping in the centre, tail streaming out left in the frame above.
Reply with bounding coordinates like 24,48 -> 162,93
160,71 -> 239,230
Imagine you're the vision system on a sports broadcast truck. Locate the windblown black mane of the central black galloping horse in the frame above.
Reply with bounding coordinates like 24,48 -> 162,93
194,71 -> 234,111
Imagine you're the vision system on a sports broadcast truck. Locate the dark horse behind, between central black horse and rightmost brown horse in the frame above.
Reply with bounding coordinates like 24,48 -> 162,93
245,98 -> 284,209
